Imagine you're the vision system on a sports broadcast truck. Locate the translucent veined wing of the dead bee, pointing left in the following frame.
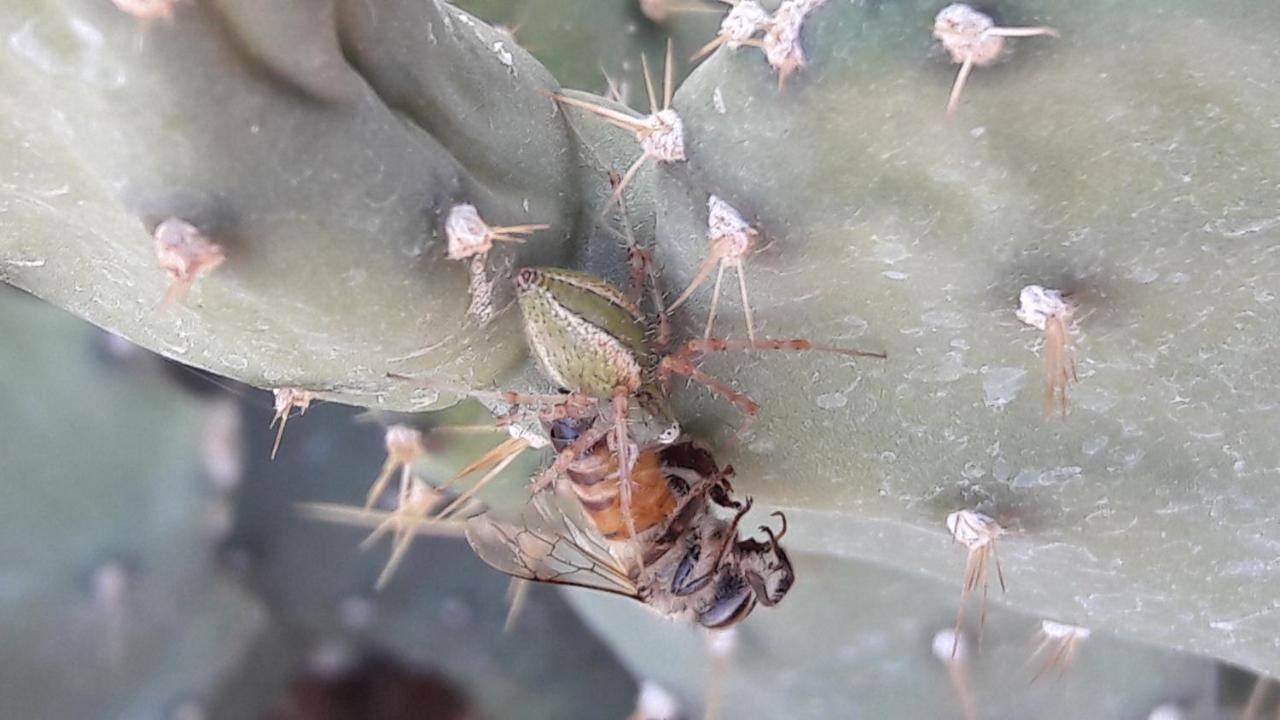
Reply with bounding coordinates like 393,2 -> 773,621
466,495 -> 640,600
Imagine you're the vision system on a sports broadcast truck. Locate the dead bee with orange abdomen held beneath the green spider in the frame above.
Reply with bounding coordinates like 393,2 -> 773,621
467,419 -> 795,628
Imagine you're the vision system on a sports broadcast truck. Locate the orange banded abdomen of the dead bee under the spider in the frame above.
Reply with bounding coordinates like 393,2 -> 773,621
566,442 -> 676,541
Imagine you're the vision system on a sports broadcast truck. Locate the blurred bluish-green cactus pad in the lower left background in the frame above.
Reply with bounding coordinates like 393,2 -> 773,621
0,288 -> 266,719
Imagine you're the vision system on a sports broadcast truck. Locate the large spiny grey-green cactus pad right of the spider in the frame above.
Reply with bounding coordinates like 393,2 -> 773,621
650,3 -> 1280,674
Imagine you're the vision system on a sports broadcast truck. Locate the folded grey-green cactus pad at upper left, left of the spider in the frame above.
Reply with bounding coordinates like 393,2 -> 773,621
0,0 -> 580,406
